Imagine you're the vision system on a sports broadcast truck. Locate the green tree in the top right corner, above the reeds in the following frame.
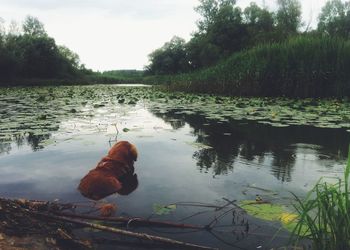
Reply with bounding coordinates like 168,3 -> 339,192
317,0 -> 350,38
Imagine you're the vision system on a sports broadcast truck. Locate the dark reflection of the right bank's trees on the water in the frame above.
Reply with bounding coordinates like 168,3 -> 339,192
154,110 -> 349,182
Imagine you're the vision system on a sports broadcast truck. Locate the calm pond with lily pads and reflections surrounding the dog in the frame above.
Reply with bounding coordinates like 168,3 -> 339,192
0,85 -> 350,249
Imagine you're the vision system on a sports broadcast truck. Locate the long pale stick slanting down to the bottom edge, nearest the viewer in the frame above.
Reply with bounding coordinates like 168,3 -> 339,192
32,212 -> 217,250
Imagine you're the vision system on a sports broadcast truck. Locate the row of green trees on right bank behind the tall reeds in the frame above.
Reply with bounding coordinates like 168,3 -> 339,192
145,0 -> 350,75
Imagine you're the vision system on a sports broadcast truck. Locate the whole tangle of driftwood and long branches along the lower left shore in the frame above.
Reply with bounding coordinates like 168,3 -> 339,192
0,198 -> 219,250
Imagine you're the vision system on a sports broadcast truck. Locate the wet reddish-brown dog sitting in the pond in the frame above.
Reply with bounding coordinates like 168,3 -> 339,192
78,141 -> 138,200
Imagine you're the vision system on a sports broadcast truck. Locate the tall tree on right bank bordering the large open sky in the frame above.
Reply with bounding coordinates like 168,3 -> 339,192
187,0 -> 247,69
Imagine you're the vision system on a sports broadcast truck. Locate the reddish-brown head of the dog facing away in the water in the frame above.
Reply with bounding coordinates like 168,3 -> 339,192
108,141 -> 138,166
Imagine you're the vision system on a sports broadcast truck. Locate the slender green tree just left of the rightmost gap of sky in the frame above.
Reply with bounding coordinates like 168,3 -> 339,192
276,0 -> 302,36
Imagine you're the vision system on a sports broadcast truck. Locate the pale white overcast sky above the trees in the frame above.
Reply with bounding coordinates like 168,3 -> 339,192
0,0 -> 326,71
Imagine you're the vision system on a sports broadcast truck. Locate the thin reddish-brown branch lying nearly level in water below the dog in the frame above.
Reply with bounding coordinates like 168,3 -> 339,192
54,212 -> 206,229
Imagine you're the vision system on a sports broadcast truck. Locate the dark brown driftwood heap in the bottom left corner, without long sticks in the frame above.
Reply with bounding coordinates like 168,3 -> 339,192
0,198 -> 91,249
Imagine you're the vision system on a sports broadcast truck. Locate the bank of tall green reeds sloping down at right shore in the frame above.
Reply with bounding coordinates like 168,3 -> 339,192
154,36 -> 350,97
